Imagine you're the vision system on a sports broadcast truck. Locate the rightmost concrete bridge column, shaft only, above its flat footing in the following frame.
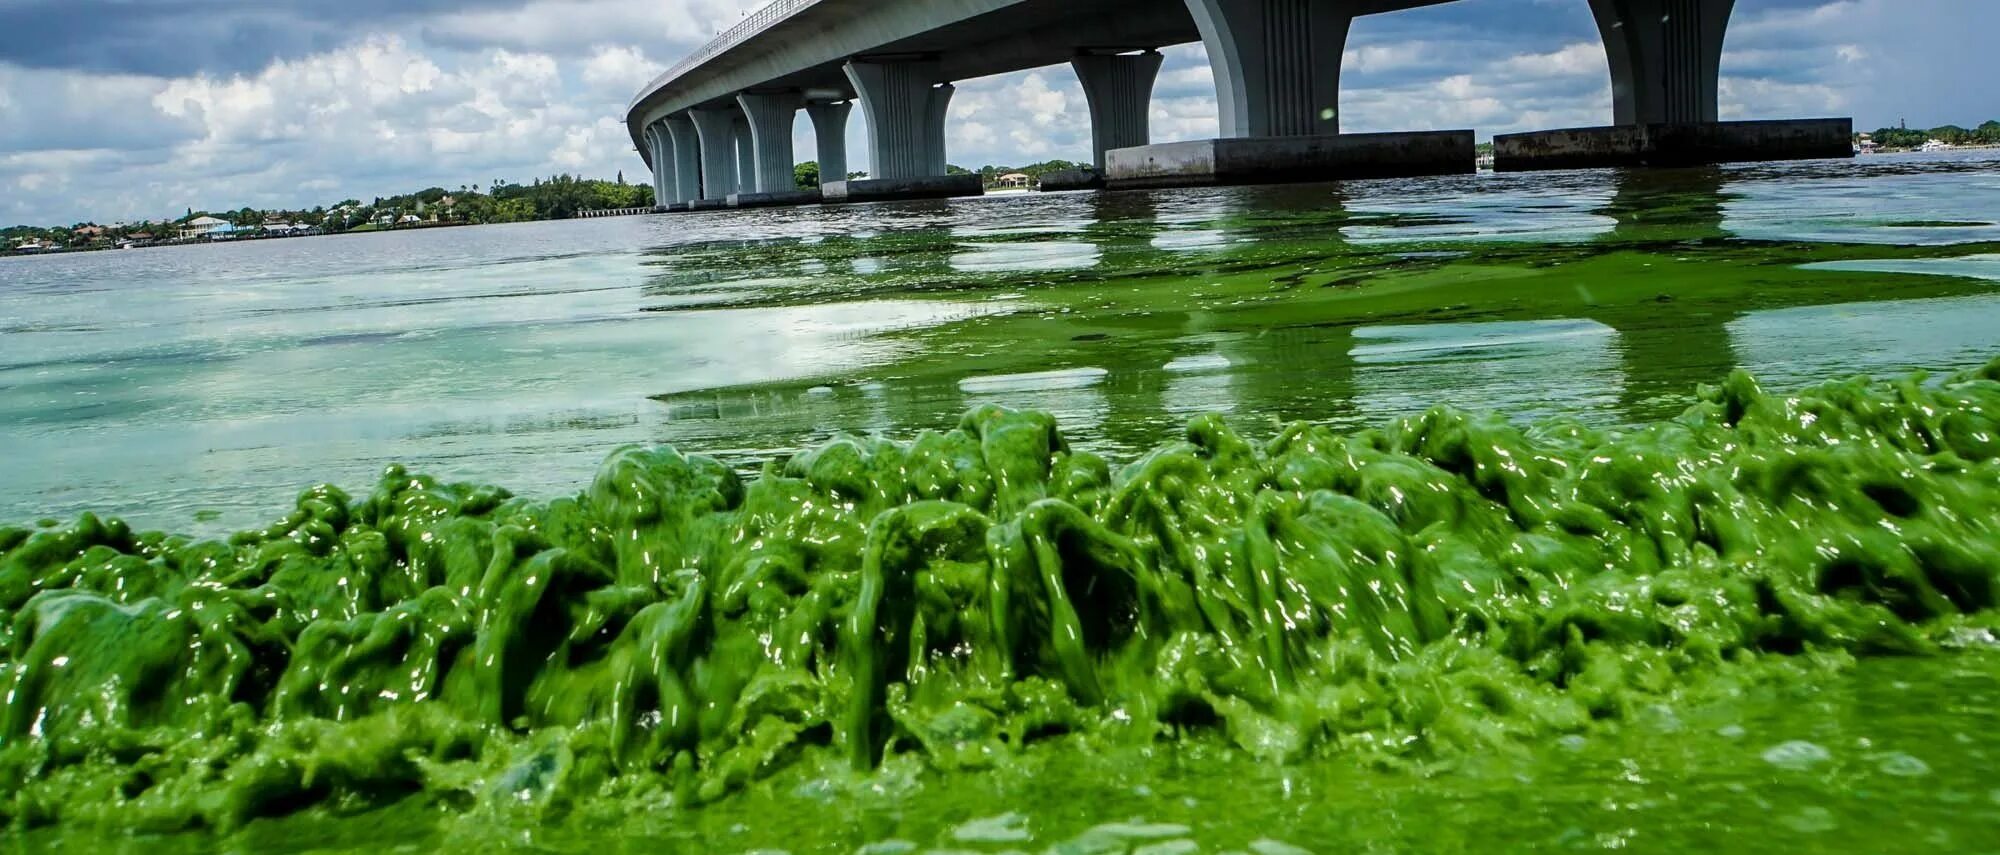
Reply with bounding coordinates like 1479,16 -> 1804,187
1590,0 -> 1736,124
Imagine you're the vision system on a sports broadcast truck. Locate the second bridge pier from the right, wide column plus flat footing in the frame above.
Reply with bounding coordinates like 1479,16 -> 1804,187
1104,0 -> 1474,188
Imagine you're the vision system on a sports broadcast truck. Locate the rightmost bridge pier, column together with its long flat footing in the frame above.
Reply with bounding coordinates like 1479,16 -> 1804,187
1494,0 -> 1854,172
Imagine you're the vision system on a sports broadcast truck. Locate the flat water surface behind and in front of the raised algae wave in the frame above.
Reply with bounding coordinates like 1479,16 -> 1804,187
0,152 -> 2000,853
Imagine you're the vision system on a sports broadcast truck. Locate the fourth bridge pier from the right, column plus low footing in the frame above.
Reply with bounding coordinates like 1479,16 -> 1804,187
820,58 -> 982,202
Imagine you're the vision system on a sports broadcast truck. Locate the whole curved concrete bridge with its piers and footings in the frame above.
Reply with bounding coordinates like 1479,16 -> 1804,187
626,0 -> 1852,210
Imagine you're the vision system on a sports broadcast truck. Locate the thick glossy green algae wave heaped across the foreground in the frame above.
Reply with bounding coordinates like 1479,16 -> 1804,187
0,362 -> 2000,831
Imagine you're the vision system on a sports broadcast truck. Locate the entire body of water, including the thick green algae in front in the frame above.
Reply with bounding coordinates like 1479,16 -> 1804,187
0,160 -> 2000,853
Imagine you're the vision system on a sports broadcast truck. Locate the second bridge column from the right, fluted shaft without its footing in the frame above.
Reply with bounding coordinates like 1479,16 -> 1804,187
1186,0 -> 1354,138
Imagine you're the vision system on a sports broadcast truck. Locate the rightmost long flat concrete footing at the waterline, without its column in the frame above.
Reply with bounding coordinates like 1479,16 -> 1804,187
1494,118 -> 1854,172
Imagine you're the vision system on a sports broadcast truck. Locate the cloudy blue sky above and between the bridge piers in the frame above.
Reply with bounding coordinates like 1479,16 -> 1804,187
0,0 -> 2000,224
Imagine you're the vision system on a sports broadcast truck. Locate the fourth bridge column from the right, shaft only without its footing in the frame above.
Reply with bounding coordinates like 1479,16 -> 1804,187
844,60 -> 952,180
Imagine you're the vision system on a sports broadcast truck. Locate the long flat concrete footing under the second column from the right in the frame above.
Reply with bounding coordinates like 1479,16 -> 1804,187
1104,130 -> 1476,190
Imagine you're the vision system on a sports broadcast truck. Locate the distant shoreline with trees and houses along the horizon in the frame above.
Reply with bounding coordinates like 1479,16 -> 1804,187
0,120 -> 2000,256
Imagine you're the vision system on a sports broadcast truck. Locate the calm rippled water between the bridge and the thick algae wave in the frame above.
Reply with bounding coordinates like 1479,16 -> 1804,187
0,151 -> 2000,529
